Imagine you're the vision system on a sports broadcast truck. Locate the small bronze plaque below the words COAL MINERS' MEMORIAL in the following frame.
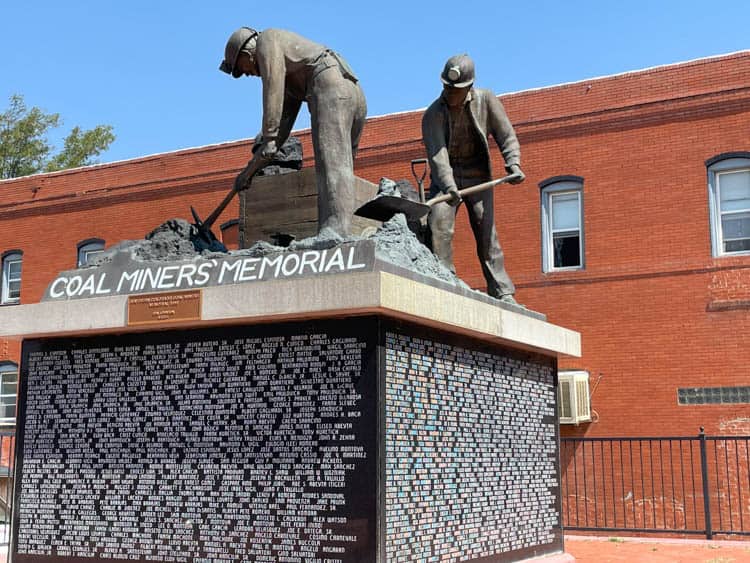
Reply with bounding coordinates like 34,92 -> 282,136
128,289 -> 201,326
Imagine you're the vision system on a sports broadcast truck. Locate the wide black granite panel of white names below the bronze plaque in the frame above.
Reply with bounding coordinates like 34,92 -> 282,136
12,319 -> 378,563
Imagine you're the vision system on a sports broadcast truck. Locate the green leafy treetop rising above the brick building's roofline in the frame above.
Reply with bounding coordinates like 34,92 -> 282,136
0,94 -> 115,180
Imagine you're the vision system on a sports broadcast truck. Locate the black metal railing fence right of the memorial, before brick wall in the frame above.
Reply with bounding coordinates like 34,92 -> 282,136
560,428 -> 750,539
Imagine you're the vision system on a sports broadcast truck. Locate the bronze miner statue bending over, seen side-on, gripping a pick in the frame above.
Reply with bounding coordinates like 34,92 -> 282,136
220,27 -> 367,236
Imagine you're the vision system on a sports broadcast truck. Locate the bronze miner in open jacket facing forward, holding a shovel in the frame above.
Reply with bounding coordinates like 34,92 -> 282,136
422,55 -> 524,304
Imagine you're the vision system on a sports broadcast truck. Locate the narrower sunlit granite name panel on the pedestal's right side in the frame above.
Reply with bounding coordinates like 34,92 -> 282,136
382,325 -> 563,563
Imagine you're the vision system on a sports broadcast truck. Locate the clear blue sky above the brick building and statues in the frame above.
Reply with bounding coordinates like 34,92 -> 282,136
0,0 -> 750,162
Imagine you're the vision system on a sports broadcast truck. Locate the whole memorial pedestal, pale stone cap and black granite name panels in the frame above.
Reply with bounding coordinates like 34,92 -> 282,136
2,260 -> 580,563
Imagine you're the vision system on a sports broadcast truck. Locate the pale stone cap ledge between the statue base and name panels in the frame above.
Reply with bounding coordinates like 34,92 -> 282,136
0,271 -> 581,357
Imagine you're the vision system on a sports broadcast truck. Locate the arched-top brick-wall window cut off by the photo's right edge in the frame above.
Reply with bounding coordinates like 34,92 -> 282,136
706,153 -> 750,256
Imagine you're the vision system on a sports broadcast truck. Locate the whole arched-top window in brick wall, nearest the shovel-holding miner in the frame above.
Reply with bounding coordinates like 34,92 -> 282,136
539,176 -> 584,272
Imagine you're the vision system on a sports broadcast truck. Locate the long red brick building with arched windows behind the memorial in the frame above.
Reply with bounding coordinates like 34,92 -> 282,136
0,51 -> 750,436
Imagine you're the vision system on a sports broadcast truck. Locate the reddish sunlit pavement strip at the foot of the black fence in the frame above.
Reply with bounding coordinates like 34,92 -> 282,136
565,535 -> 750,563
